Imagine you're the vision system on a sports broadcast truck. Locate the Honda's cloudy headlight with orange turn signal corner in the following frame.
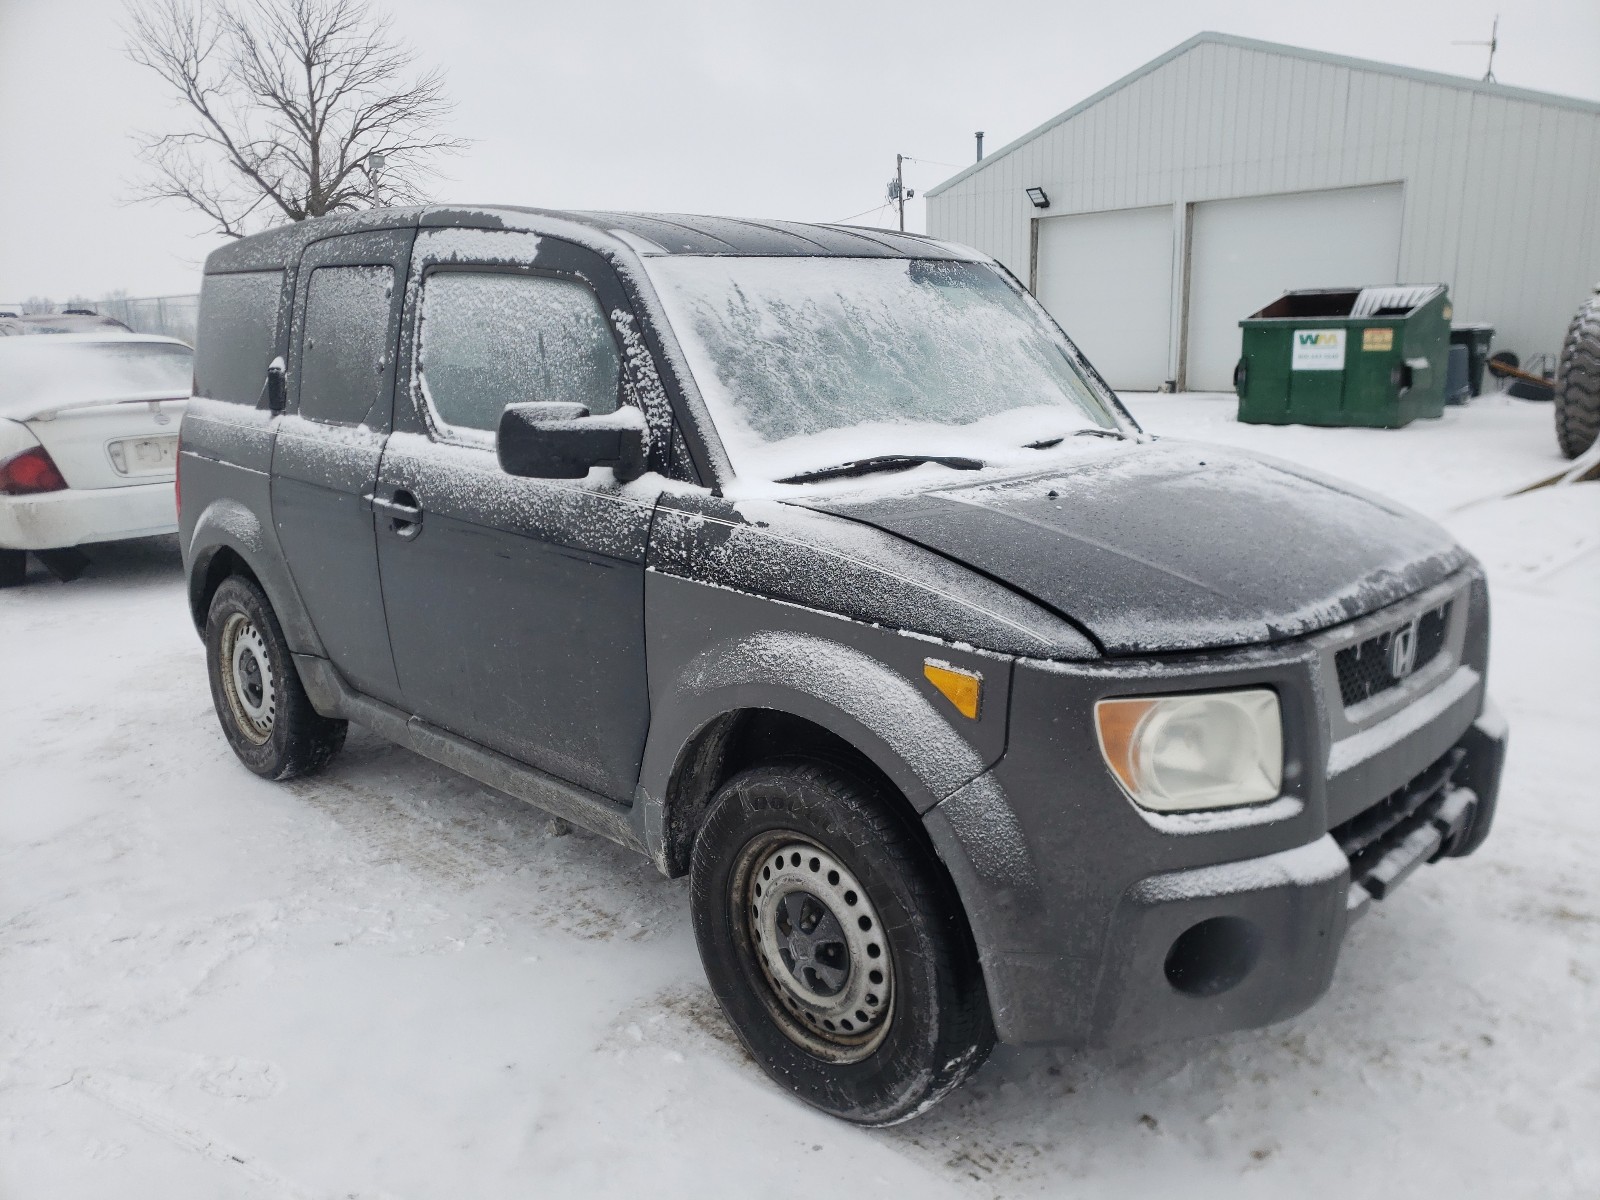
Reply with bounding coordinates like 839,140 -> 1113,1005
1094,688 -> 1283,813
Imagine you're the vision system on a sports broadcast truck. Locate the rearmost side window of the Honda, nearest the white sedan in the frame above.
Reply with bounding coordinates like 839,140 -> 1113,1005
195,270 -> 283,405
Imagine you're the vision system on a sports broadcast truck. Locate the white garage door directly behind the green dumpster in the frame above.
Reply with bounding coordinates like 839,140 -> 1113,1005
1184,184 -> 1400,392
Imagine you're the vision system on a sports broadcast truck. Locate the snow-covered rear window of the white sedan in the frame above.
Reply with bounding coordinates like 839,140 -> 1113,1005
0,334 -> 195,414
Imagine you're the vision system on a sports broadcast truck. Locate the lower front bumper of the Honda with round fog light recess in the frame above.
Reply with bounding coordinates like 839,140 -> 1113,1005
928,707 -> 1506,1046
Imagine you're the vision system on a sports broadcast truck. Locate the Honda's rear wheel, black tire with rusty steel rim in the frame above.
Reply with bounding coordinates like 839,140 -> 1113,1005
205,574 -> 349,779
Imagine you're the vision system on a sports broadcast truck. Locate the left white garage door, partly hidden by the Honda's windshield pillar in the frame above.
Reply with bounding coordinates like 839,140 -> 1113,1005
1035,205 -> 1173,392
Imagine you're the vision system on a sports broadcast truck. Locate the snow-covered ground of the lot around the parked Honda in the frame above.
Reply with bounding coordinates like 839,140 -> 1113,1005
0,397 -> 1600,1200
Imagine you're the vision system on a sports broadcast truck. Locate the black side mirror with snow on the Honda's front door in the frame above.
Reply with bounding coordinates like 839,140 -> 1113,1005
494,402 -> 648,483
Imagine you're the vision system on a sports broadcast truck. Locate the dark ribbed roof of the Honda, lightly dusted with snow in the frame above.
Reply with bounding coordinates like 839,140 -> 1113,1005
206,205 -> 981,274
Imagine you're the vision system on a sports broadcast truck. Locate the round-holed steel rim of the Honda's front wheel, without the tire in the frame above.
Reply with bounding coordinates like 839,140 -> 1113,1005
736,832 -> 894,1062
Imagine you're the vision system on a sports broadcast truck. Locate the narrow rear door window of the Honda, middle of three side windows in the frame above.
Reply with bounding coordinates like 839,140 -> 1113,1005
299,267 -> 395,426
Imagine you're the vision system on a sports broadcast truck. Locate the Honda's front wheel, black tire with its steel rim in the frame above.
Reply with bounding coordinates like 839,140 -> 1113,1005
690,760 -> 994,1125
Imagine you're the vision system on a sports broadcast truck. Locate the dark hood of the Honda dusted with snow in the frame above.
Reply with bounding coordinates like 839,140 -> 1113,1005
803,442 -> 1469,654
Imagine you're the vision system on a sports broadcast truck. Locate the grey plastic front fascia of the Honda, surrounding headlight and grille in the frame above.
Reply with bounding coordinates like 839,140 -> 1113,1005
923,568 -> 1506,1046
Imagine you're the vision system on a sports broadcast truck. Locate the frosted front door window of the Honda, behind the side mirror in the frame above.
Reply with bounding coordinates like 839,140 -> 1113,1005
419,270 -> 622,430
